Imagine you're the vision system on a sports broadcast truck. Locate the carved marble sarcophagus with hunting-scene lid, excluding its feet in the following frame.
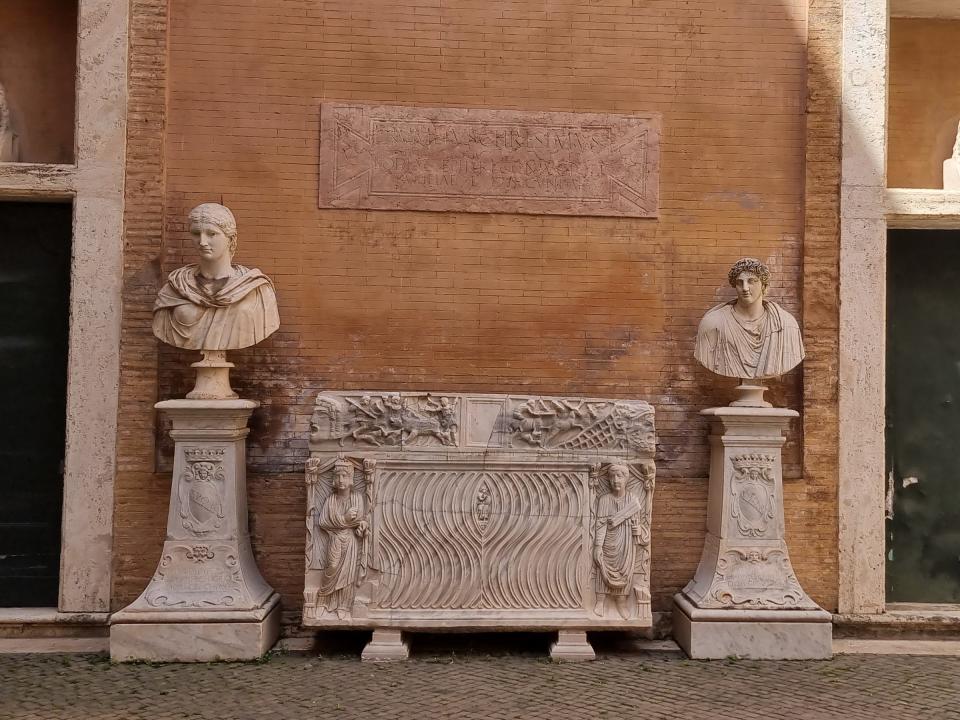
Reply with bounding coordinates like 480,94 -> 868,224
303,391 -> 655,629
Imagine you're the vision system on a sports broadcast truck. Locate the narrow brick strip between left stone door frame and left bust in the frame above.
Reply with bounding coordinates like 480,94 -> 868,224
111,0 -> 170,610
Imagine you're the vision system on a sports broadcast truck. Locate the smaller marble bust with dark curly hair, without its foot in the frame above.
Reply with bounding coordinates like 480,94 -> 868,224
694,258 -> 804,404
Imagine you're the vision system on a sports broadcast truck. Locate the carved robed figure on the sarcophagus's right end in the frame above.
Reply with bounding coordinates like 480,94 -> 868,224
593,464 -> 649,619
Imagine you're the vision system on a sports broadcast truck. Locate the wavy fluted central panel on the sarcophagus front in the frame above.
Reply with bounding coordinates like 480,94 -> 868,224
376,470 -> 588,610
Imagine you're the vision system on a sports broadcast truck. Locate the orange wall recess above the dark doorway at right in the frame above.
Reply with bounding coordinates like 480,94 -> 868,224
887,18 -> 960,189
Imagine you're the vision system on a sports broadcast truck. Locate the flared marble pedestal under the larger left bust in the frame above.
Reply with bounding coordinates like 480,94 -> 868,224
110,400 -> 280,662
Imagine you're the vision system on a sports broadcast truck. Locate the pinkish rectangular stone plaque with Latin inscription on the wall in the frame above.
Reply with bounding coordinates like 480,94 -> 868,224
320,103 -> 660,217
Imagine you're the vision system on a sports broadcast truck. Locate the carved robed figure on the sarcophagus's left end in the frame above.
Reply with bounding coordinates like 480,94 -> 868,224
313,458 -> 368,620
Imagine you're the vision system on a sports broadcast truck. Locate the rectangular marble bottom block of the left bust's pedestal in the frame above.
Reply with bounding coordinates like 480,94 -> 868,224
110,594 -> 280,662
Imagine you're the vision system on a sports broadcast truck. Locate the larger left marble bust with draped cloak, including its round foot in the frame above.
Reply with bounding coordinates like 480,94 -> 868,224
153,203 -> 280,399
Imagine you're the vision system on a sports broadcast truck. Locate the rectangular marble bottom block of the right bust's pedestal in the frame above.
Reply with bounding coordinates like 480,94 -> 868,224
673,594 -> 833,660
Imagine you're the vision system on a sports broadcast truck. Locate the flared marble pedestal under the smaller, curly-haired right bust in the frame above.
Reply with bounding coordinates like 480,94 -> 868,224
674,407 -> 832,659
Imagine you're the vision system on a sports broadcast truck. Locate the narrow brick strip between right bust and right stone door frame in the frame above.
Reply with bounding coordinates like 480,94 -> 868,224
785,0 -> 843,610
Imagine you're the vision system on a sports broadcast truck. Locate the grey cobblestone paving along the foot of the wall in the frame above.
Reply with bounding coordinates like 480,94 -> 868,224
0,636 -> 960,720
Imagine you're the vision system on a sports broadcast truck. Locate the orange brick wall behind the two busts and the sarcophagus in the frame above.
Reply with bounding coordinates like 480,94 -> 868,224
114,0 -> 839,610
